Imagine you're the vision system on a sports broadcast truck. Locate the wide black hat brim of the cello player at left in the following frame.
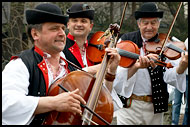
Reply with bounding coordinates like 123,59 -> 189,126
26,9 -> 68,25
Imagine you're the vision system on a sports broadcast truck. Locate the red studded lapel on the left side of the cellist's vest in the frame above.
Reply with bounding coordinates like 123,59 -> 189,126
38,59 -> 49,95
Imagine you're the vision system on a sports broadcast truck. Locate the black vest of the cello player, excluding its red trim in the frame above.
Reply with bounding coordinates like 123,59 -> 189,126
17,47 -> 76,125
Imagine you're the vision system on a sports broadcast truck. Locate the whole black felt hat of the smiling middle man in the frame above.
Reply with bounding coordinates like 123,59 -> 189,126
67,3 -> 94,20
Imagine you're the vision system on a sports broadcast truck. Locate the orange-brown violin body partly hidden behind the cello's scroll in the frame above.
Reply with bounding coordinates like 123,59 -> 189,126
87,31 -> 140,68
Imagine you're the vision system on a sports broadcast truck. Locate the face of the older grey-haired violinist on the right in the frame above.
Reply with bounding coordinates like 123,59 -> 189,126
137,18 -> 160,39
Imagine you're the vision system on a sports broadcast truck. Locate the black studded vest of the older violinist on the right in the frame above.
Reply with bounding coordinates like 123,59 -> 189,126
121,30 -> 169,113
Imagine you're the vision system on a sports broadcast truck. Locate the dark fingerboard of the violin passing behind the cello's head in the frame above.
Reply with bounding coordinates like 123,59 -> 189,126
117,48 -> 139,59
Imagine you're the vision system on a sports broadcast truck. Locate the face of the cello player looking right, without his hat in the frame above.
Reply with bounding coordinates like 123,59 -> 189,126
33,22 -> 66,53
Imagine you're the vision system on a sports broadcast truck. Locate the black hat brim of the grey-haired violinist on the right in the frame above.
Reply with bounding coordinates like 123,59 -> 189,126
135,11 -> 164,20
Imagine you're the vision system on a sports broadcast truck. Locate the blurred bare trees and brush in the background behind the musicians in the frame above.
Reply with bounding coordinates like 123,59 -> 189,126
2,2 -> 188,68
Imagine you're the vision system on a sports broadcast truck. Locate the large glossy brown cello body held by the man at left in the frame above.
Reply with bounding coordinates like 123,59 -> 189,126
43,71 -> 113,125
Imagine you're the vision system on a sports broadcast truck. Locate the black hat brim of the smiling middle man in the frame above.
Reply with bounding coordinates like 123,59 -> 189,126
67,10 -> 94,20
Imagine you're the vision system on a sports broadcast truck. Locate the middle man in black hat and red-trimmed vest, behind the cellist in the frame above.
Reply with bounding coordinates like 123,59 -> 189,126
63,3 -> 94,68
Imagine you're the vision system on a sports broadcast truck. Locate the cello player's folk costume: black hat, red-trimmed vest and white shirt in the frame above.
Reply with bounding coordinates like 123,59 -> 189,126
2,3 -> 72,125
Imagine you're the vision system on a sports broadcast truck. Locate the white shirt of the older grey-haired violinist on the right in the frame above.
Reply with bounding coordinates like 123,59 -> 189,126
112,45 -> 186,110
